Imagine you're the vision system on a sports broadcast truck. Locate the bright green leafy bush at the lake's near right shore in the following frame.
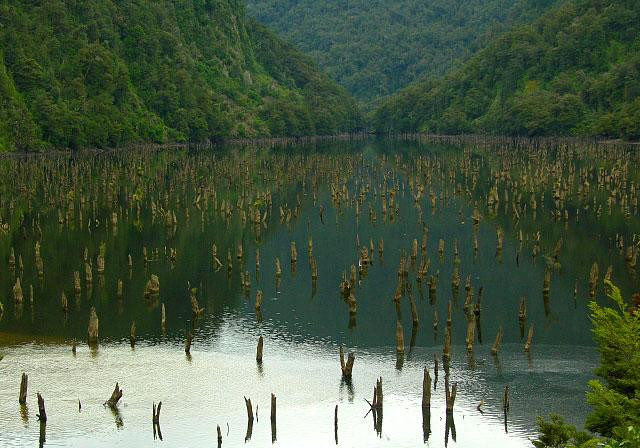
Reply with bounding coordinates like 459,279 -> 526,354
533,280 -> 640,448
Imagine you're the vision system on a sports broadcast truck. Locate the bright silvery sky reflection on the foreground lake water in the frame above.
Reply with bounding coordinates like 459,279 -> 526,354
0,328 -> 596,447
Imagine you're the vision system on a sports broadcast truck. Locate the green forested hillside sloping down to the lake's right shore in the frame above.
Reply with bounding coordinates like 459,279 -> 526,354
373,0 -> 640,139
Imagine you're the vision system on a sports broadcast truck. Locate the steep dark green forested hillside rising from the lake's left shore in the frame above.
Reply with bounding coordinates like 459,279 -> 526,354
0,0 -> 361,150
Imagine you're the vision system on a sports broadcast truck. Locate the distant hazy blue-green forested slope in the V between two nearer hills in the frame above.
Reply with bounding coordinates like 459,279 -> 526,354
247,0 -> 557,107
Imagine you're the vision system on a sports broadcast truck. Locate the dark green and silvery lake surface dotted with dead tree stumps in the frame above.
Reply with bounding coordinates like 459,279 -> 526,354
0,141 -> 640,447
